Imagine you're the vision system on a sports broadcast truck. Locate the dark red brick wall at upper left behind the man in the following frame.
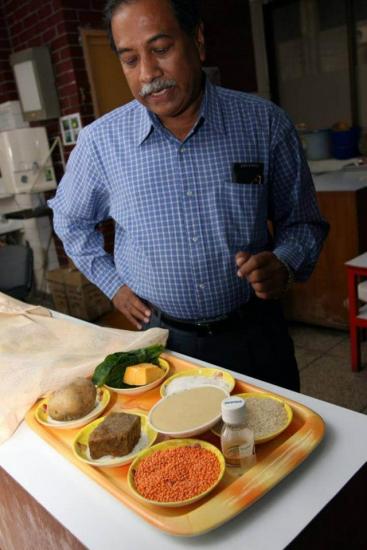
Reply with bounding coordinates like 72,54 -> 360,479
2,0 -> 104,144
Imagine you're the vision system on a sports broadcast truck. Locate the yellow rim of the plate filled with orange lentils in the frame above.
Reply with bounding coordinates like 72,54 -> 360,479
127,439 -> 225,508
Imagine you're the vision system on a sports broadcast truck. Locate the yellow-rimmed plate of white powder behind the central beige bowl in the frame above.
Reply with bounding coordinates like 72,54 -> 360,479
160,367 -> 235,397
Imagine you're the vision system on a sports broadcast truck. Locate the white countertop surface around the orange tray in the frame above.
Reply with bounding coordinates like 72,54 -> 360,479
0,354 -> 367,550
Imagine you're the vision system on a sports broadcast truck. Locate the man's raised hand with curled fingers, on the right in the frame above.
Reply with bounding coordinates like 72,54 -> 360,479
236,251 -> 288,300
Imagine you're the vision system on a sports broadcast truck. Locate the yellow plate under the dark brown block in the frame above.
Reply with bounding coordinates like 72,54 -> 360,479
73,410 -> 158,468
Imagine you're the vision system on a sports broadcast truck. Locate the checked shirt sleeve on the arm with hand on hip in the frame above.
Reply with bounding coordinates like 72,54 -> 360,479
48,128 -> 124,299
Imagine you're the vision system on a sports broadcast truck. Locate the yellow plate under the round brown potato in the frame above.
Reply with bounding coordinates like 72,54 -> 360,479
35,388 -> 111,430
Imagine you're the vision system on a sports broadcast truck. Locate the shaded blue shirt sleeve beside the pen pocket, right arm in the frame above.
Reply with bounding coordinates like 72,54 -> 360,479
269,109 -> 329,281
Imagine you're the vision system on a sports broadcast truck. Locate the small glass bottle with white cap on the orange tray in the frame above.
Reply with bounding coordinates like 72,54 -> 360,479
220,396 -> 256,475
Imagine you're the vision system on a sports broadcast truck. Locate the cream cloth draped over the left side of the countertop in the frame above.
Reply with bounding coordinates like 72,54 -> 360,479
0,292 -> 168,444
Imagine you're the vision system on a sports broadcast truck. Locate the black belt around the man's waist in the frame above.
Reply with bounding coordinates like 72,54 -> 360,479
151,298 -> 259,334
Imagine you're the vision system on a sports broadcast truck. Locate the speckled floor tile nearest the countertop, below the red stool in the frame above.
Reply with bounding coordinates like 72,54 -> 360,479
300,354 -> 367,411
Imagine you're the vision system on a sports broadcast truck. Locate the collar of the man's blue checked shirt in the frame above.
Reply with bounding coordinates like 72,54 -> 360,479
136,77 -> 226,145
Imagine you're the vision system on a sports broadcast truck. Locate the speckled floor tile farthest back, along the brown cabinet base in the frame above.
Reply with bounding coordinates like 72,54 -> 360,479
289,325 -> 347,352
